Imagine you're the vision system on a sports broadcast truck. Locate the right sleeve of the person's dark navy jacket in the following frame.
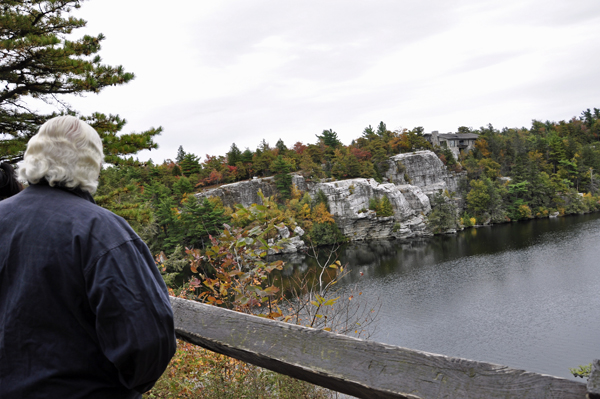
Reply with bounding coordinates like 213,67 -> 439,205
85,238 -> 176,393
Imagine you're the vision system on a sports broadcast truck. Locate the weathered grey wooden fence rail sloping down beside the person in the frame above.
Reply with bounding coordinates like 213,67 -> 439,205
171,297 -> 600,399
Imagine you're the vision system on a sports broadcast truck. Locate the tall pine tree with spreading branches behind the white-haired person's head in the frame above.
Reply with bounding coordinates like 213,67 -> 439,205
0,0 -> 162,164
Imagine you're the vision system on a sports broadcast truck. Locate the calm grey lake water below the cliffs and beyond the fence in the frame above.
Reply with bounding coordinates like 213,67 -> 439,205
284,214 -> 600,381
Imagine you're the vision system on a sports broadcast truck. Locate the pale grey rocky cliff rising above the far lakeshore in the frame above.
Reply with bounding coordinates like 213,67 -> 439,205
198,151 -> 463,244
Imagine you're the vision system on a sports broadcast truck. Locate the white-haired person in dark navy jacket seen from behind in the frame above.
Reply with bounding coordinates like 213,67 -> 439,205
0,116 -> 176,399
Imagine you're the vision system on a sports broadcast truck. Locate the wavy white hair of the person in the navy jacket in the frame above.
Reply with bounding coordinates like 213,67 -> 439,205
18,115 -> 104,194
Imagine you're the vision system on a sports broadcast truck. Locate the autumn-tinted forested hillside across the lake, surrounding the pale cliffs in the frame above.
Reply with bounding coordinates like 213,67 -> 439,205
97,108 -> 600,253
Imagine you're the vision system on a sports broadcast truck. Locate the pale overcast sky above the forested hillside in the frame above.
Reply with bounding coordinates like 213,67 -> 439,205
61,0 -> 600,162
